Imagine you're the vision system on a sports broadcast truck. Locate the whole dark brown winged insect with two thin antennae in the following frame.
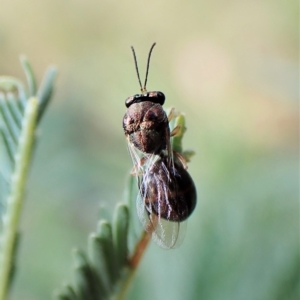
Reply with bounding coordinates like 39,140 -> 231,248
123,43 -> 197,249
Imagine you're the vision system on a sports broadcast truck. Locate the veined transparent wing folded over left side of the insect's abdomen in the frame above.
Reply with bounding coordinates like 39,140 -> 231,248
137,158 -> 187,249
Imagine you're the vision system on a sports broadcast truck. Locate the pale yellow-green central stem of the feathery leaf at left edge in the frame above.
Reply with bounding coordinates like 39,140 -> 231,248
0,97 -> 38,300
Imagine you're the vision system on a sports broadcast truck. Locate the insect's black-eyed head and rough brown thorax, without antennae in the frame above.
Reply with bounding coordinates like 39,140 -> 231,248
123,92 -> 170,154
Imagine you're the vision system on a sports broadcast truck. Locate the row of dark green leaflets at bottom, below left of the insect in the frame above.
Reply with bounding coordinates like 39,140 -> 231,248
56,203 -> 129,300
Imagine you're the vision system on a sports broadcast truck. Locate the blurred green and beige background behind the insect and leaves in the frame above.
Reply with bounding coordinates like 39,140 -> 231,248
0,0 -> 299,300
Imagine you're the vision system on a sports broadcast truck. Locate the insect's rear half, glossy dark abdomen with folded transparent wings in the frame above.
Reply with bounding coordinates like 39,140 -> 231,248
128,137 -> 196,249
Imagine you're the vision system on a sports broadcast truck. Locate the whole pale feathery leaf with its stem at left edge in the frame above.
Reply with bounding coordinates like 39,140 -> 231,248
0,57 -> 56,300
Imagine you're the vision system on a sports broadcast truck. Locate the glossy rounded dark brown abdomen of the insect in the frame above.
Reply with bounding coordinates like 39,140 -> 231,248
140,159 -> 197,222
